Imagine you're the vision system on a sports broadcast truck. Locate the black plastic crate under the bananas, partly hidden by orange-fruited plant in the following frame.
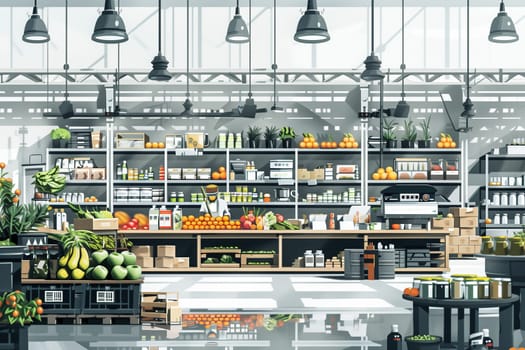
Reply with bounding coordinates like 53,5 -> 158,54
23,284 -> 85,315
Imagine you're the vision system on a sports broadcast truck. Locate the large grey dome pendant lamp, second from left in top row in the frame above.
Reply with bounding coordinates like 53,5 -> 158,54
91,0 -> 128,44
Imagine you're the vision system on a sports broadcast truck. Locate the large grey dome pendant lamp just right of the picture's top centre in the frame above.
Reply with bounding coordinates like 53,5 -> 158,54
293,0 -> 330,44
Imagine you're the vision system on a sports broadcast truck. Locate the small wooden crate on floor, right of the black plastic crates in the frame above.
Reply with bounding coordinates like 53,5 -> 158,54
140,292 -> 182,324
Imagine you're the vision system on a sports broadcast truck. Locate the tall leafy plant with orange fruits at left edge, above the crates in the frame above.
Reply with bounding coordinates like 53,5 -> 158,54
0,163 -> 48,245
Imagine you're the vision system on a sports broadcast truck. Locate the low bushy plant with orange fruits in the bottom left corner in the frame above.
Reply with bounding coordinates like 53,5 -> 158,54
0,290 -> 44,327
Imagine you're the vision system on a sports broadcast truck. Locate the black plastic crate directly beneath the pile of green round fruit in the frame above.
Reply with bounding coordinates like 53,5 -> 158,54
82,284 -> 140,315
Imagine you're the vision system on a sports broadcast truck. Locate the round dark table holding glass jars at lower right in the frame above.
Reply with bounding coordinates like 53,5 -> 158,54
403,294 -> 519,350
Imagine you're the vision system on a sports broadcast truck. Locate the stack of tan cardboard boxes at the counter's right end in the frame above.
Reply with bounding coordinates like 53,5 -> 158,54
449,208 -> 481,255
